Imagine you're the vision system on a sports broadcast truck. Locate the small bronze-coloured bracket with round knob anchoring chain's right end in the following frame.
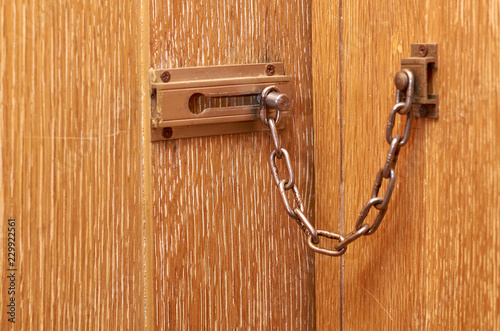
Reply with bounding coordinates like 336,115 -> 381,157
394,44 -> 439,118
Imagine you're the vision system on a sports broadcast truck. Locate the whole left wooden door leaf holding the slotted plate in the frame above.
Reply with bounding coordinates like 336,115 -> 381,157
0,0 -> 315,330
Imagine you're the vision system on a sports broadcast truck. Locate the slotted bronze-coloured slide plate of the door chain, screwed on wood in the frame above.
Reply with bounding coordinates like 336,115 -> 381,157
150,63 -> 292,141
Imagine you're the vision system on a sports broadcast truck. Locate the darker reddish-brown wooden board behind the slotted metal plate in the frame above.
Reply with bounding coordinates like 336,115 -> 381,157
150,0 -> 315,330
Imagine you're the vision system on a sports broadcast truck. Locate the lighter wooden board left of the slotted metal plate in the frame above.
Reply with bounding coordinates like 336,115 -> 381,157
0,0 -> 144,330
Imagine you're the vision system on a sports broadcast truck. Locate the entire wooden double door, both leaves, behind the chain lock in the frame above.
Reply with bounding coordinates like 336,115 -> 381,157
0,0 -> 500,330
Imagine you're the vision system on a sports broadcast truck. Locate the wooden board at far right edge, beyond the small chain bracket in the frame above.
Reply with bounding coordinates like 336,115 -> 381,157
424,0 -> 500,330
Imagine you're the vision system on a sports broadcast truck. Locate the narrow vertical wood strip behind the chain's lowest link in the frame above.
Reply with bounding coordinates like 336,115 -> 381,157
311,1 -> 343,330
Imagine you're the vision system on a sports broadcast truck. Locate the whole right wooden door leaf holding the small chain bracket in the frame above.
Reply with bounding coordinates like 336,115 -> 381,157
312,0 -> 500,330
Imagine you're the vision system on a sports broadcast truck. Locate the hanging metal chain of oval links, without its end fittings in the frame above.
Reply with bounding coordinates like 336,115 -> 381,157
260,69 -> 414,256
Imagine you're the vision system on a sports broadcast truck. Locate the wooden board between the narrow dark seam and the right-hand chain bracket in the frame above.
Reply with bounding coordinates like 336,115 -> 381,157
343,1 -> 428,330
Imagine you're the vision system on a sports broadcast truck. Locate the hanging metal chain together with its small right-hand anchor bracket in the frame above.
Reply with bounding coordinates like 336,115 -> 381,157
260,44 -> 438,256
